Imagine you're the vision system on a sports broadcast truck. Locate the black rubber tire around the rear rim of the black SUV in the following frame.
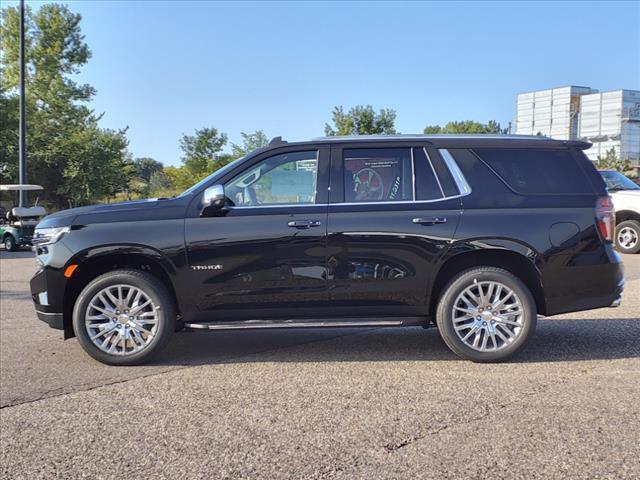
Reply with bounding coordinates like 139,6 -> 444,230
436,266 -> 538,362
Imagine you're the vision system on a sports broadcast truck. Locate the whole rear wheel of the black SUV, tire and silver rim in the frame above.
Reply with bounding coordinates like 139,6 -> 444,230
436,266 -> 537,362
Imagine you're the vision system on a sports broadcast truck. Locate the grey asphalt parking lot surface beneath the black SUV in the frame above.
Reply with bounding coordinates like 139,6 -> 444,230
0,251 -> 640,479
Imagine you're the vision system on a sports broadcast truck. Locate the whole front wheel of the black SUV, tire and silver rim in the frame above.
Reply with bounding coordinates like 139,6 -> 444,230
73,270 -> 176,365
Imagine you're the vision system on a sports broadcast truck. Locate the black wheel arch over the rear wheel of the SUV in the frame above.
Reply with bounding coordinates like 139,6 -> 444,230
429,244 -> 546,316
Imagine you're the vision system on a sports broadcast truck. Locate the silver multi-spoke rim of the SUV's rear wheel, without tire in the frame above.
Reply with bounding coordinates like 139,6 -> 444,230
451,281 -> 524,352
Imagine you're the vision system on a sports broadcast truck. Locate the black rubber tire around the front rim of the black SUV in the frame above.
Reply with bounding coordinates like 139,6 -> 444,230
73,270 -> 176,365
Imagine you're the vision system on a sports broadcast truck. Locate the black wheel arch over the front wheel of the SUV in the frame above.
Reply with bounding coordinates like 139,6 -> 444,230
62,245 -> 180,339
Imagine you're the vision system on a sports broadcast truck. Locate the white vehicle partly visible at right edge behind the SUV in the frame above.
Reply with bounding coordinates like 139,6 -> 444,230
600,170 -> 640,253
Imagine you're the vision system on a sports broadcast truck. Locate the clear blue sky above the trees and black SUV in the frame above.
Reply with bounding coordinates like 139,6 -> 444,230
5,0 -> 640,164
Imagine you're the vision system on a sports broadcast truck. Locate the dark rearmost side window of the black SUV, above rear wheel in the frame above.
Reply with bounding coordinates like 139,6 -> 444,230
474,148 -> 592,194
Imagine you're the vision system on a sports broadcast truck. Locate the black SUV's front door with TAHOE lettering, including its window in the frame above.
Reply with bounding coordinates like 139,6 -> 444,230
185,147 -> 329,320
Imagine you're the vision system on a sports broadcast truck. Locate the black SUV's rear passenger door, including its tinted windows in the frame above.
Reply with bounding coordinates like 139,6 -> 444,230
327,143 -> 463,316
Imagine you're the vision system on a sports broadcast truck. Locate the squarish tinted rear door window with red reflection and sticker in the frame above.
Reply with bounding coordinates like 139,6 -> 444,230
343,148 -> 413,202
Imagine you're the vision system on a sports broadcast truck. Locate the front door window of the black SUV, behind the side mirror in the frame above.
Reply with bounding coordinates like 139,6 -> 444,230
224,150 -> 318,207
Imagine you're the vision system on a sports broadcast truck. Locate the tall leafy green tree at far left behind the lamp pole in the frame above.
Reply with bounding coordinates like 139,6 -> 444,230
0,4 -> 133,207
